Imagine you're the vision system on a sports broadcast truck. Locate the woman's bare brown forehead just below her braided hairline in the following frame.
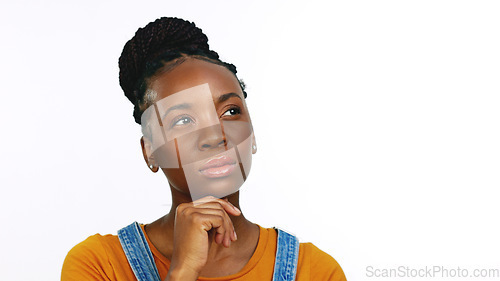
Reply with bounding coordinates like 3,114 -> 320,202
150,59 -> 243,100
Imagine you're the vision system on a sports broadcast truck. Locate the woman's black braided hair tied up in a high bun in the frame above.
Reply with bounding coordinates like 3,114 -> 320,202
118,17 -> 247,124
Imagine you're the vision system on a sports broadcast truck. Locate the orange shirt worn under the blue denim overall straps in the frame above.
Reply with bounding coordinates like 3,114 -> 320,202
61,224 -> 346,281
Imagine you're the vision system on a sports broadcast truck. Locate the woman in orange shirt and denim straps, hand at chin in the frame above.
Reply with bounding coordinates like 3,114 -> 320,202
62,18 -> 345,281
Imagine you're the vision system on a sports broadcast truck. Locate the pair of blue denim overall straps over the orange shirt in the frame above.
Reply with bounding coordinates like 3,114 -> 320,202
118,222 -> 299,281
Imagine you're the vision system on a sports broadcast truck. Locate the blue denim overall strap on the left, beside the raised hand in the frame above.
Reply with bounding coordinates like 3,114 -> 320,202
118,222 -> 161,281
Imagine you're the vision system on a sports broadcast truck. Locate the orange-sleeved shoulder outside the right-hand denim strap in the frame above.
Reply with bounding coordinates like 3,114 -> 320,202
299,242 -> 346,281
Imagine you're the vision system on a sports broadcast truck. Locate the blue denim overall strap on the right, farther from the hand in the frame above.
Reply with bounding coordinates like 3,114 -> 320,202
273,227 -> 300,281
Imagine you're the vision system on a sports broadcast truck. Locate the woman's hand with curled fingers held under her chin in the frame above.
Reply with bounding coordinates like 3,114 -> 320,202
166,196 -> 241,281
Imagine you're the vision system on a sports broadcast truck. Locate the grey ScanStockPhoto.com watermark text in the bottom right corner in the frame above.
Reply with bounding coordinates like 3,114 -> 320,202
366,265 -> 500,278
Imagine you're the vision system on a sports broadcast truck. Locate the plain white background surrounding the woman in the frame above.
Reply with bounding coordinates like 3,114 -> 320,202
0,1 -> 500,280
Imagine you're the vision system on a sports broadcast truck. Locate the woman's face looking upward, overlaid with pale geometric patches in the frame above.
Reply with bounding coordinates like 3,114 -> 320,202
141,59 -> 255,200
